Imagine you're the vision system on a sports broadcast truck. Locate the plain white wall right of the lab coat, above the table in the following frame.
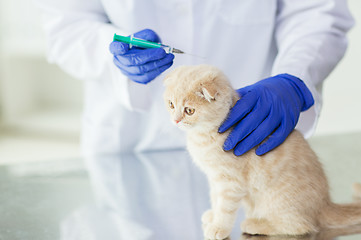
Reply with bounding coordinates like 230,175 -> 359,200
316,0 -> 361,135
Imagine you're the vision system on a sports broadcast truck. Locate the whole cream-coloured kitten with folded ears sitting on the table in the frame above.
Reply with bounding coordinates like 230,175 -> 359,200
164,65 -> 361,239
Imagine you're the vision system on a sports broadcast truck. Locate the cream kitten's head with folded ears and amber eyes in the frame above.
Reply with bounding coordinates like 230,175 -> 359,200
164,65 -> 237,131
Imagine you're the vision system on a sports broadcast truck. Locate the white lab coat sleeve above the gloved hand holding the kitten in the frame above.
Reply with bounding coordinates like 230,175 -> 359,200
272,0 -> 354,137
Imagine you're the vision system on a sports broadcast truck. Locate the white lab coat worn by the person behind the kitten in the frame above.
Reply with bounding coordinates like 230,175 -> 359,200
40,0 -> 353,153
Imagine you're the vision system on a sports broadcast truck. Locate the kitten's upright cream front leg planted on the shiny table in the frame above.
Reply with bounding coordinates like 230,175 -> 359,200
202,184 -> 243,239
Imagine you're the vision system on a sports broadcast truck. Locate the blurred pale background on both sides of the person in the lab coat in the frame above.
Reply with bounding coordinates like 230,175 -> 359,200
0,0 -> 361,164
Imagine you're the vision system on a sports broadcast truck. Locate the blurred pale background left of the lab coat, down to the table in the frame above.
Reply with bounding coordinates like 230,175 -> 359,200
0,0 -> 82,164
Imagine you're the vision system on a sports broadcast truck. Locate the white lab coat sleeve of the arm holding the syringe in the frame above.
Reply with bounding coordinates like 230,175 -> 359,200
37,0 -> 149,110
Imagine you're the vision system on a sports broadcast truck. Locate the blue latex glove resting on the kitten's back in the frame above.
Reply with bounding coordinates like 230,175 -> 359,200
219,74 -> 314,156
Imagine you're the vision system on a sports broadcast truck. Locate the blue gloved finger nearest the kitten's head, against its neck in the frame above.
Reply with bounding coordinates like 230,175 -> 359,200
218,91 -> 258,133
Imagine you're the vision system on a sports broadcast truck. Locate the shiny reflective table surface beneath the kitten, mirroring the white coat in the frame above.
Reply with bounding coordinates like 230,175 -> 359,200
0,133 -> 361,240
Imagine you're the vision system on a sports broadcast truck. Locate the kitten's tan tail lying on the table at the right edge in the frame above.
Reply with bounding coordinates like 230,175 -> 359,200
321,183 -> 361,229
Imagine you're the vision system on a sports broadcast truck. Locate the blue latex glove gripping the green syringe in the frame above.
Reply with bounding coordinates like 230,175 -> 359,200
109,29 -> 174,84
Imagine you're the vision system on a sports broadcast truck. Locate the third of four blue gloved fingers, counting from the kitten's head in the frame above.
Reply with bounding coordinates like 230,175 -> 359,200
234,109 -> 280,156
